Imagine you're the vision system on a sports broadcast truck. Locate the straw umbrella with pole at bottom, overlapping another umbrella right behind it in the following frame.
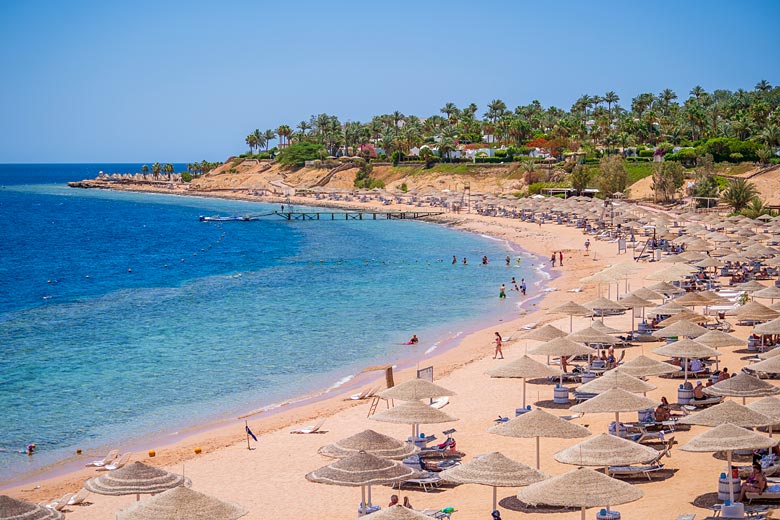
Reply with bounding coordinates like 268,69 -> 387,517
306,453 -> 417,514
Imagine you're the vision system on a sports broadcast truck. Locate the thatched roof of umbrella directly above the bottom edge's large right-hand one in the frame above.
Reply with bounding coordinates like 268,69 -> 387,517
553,433 -> 658,466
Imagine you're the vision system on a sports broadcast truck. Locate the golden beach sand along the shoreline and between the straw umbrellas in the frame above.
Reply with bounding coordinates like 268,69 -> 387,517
4,185 -> 772,520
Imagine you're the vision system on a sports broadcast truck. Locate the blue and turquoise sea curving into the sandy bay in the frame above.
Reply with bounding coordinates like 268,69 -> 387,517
0,164 -> 540,481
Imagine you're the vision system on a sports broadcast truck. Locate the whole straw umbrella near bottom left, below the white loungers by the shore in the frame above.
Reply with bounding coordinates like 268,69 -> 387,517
84,461 -> 192,500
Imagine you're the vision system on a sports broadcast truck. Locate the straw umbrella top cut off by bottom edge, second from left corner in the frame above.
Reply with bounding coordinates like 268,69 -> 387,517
116,486 -> 249,520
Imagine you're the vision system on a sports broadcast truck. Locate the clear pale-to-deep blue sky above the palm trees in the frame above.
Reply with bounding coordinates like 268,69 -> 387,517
0,0 -> 780,162
